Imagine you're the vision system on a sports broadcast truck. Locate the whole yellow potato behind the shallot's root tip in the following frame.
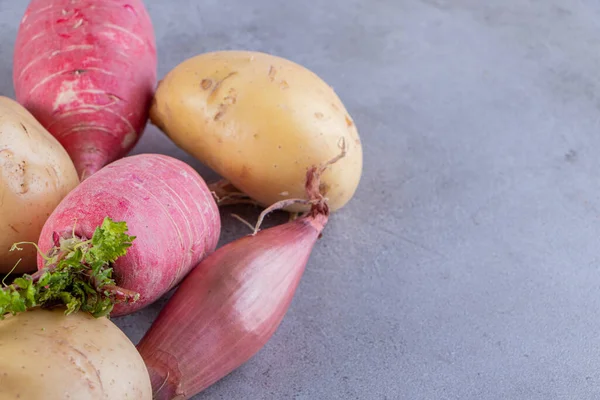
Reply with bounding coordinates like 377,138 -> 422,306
150,51 -> 363,211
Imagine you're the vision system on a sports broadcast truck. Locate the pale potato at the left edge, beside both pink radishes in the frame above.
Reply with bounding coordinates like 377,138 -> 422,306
0,96 -> 79,274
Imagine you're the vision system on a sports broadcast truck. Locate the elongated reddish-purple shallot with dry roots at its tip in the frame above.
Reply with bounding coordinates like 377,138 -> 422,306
137,158 -> 338,400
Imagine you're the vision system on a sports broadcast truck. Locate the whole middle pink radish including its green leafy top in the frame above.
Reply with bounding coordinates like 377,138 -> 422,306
0,154 -> 221,317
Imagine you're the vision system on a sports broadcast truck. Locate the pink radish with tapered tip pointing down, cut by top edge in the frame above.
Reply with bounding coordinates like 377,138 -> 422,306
13,0 -> 157,179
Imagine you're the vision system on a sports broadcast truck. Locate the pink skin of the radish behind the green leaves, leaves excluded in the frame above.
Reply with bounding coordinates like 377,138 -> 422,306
38,154 -> 221,316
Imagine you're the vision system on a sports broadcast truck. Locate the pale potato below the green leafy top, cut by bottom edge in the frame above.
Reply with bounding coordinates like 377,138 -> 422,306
0,309 -> 152,400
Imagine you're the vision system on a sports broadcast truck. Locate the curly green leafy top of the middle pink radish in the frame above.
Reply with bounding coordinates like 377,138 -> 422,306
0,217 -> 139,320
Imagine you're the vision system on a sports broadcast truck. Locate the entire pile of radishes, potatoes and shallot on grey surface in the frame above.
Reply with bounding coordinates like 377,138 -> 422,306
0,0 -> 363,400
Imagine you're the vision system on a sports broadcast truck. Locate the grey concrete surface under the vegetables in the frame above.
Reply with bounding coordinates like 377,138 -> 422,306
0,0 -> 600,400
